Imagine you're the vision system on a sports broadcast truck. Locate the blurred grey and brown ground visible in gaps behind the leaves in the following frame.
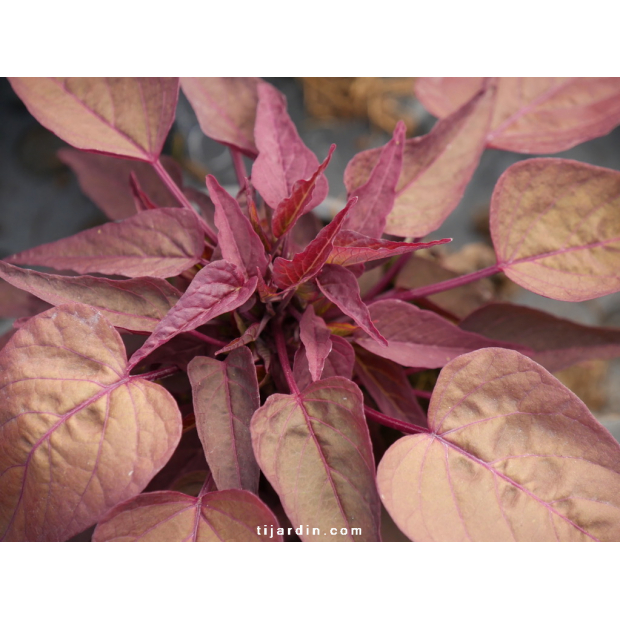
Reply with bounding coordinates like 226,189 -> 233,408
0,78 -> 620,440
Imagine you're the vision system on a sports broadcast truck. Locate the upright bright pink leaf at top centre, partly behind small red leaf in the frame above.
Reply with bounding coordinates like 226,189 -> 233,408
252,83 -> 329,211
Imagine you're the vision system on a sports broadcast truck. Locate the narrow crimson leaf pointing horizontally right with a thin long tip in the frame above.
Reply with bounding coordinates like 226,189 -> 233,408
327,230 -> 452,267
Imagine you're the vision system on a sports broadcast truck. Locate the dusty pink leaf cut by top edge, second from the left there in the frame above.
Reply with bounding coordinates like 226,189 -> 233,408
181,77 -> 263,157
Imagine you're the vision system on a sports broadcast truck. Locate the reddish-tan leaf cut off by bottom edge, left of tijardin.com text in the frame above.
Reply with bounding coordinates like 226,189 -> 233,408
93,490 -> 282,542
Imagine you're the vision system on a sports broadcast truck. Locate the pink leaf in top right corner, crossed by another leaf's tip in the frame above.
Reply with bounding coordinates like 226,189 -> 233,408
415,77 -> 620,155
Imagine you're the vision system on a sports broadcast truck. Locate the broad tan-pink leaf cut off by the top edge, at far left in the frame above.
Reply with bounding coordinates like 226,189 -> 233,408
9,77 -> 179,162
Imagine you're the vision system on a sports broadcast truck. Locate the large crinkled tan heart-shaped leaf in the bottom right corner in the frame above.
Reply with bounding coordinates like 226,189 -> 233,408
377,348 -> 620,541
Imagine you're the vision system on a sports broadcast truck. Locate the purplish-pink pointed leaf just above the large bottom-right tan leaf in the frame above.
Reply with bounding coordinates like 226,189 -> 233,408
356,299 -> 532,368
